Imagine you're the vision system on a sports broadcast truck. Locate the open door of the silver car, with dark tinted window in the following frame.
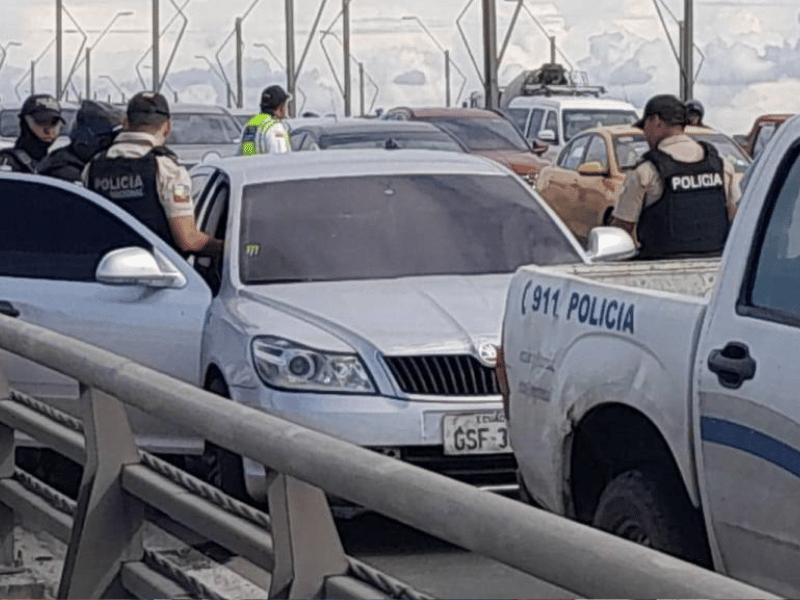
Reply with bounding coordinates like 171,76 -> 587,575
0,176 -> 211,450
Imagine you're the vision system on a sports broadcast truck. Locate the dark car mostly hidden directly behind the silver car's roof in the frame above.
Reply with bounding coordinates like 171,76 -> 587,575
290,118 -> 465,152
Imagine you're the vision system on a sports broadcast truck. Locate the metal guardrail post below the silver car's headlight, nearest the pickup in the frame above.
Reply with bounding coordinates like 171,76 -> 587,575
269,474 -> 348,598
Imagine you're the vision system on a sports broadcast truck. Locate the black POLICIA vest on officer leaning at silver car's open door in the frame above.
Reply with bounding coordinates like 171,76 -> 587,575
87,147 -> 181,252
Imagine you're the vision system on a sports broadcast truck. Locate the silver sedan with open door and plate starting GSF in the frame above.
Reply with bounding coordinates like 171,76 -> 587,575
0,150 -> 586,497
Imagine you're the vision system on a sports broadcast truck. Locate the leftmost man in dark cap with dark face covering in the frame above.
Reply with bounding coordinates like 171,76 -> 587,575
0,94 -> 64,173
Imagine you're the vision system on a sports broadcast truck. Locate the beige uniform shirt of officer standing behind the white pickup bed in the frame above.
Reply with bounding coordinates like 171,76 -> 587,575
613,134 -> 741,223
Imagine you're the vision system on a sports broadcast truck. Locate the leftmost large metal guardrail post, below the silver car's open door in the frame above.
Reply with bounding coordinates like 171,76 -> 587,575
58,385 -> 144,598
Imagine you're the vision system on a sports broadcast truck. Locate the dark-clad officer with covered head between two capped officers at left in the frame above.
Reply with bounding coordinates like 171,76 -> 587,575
38,100 -> 122,182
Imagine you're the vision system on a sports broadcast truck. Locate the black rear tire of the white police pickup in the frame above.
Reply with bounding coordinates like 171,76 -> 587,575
592,469 -> 711,567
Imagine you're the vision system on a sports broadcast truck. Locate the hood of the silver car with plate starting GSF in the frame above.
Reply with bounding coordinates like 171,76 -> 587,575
243,274 -> 511,356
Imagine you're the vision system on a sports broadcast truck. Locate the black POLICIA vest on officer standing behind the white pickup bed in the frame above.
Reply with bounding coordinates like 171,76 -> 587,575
637,142 -> 729,258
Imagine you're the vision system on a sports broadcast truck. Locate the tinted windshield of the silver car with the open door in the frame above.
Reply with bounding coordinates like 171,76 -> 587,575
240,174 -> 581,284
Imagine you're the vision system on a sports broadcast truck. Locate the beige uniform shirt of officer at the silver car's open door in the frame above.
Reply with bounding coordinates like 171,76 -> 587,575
83,131 -> 194,219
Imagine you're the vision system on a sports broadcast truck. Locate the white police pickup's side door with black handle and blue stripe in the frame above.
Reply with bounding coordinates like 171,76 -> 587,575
695,141 -> 800,597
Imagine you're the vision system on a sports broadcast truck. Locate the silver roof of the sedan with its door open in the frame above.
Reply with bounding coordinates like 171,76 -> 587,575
203,148 -> 510,184
